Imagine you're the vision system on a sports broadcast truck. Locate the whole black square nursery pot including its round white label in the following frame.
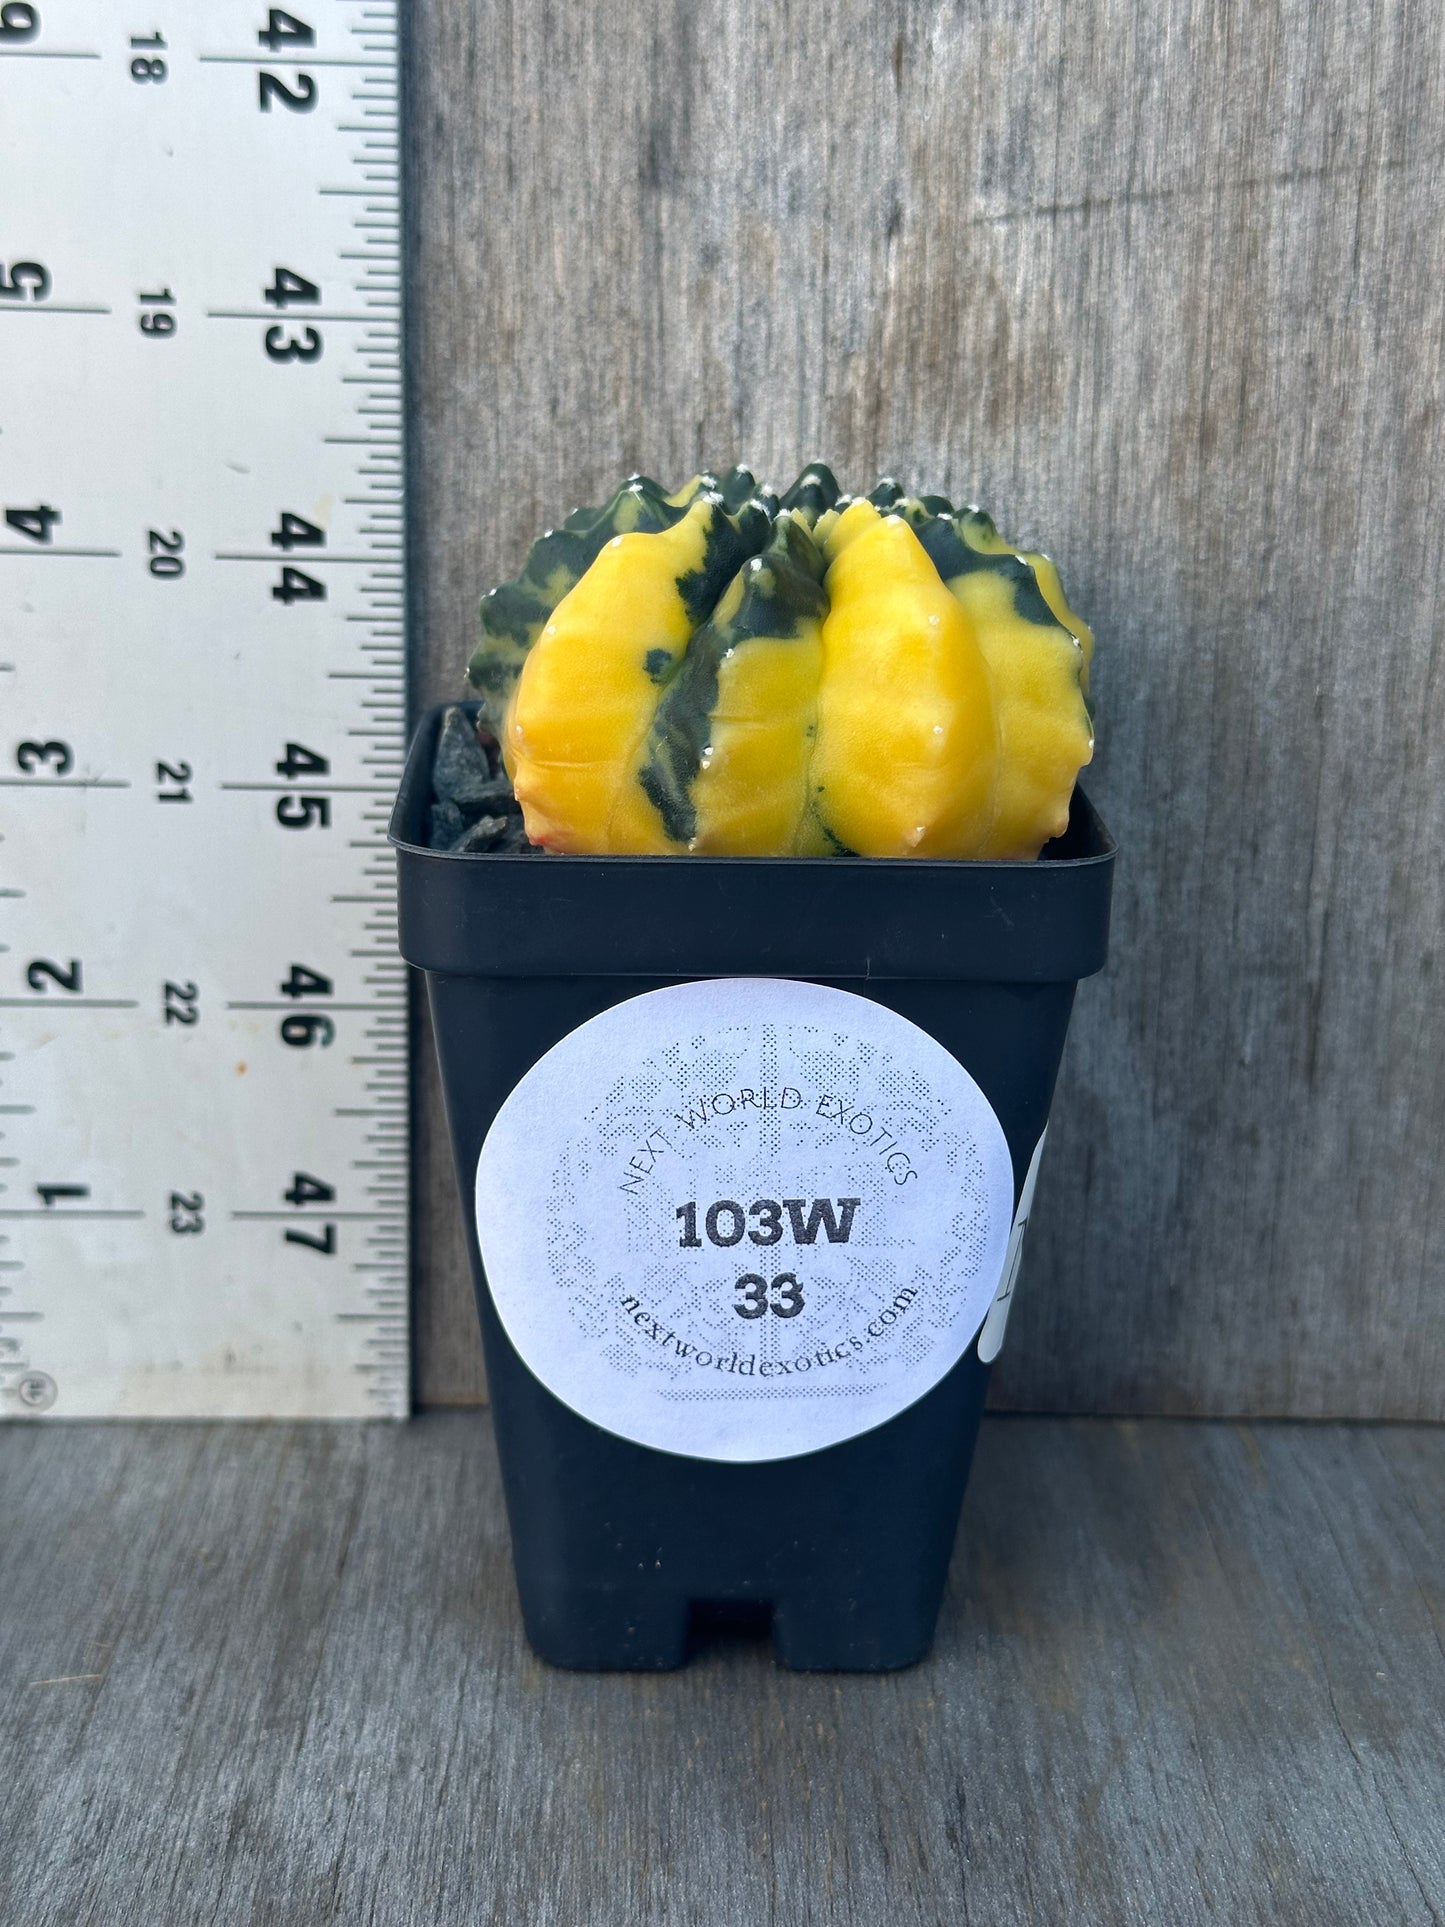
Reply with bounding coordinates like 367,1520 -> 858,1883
391,709 -> 1114,1671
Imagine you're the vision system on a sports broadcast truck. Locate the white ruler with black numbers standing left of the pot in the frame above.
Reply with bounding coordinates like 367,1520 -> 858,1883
0,0 -> 408,1416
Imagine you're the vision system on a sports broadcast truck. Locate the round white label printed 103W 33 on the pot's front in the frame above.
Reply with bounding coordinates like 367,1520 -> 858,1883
476,977 -> 1013,1461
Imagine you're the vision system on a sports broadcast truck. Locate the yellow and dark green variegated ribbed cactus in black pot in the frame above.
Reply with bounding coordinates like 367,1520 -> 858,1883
470,464 -> 1092,858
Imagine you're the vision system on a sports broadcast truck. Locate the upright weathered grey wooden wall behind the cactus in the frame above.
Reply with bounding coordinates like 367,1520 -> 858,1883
398,0 -> 1445,1418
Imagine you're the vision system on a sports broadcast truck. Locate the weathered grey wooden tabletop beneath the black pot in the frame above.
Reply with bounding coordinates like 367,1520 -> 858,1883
0,1414 -> 1445,1927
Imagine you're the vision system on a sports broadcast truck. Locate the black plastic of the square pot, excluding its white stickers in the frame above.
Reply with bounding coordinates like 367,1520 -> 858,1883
391,709 -> 1114,1671
